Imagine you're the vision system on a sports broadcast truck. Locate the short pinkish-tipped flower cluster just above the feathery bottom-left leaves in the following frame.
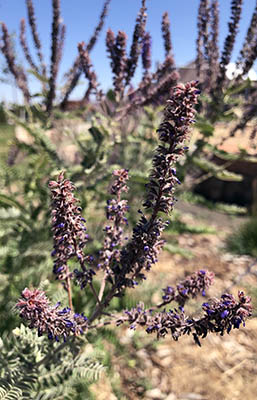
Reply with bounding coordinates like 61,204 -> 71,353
16,288 -> 88,342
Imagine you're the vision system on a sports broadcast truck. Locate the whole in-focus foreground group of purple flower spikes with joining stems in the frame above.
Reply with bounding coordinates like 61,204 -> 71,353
16,81 -> 252,345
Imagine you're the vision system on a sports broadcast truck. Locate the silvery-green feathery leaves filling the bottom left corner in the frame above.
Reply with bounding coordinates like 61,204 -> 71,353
0,325 -> 104,400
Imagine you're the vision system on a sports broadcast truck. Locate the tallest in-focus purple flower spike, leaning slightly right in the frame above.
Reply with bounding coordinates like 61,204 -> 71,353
112,82 -> 200,291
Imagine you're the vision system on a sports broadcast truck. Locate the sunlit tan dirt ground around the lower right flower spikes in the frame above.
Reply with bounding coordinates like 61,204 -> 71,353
90,204 -> 257,400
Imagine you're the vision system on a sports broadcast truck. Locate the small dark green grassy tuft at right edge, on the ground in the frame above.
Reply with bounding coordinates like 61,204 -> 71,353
227,217 -> 257,257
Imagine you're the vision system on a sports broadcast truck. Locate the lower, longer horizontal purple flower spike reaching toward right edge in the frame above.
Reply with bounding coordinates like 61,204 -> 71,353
116,292 -> 252,346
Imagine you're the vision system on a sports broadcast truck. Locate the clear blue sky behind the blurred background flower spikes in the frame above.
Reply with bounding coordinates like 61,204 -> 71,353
0,0 -> 256,101
